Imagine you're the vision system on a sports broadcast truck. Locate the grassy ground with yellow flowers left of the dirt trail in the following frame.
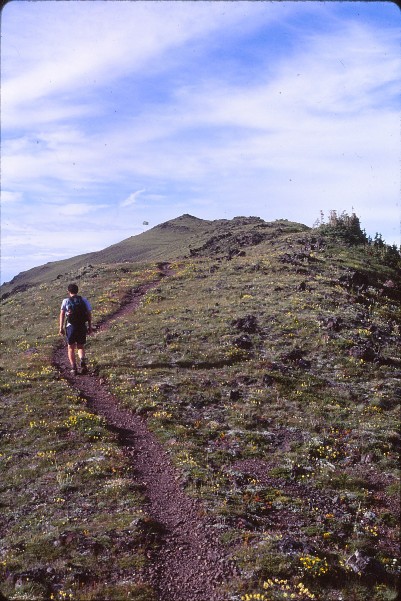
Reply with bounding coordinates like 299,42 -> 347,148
0,267 -> 162,601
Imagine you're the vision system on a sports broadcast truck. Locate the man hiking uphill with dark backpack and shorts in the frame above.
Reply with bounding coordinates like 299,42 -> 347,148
59,284 -> 92,376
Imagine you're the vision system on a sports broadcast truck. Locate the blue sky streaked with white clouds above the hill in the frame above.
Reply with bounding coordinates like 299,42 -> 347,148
1,0 -> 401,282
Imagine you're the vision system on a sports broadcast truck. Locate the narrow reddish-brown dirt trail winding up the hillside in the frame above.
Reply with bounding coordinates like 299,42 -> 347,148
53,264 -> 235,601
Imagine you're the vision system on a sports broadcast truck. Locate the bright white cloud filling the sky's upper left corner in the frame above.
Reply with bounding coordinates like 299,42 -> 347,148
2,1 -> 288,126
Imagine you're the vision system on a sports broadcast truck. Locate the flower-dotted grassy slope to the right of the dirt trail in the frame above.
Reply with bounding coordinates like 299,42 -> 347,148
91,240 -> 399,599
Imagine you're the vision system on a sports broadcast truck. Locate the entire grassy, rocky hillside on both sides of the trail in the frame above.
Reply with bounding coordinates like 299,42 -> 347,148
0,216 -> 401,601
